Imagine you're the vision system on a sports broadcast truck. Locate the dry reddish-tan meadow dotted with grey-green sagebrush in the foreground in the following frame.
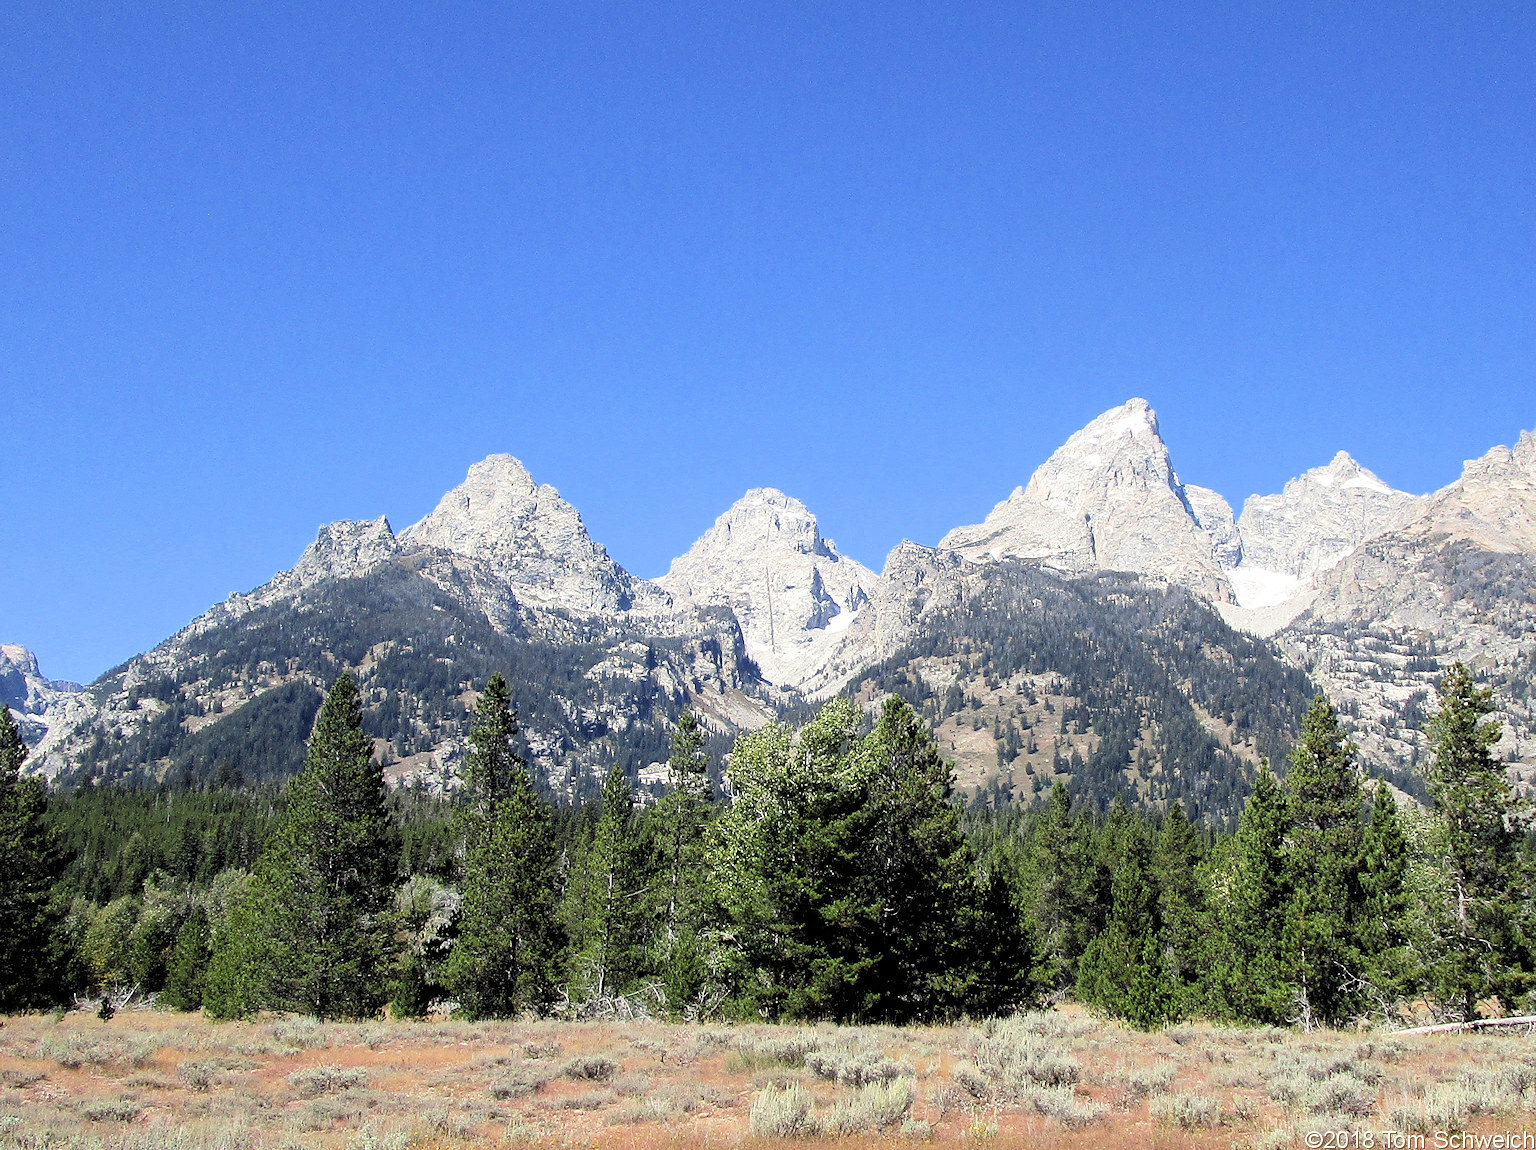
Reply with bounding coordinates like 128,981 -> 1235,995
0,1009 -> 1536,1150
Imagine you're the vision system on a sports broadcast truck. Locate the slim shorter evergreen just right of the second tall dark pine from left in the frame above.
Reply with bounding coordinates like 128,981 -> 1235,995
567,763 -> 645,1000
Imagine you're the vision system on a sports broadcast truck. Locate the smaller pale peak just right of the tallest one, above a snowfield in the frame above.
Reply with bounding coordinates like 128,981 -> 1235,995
1238,451 -> 1419,582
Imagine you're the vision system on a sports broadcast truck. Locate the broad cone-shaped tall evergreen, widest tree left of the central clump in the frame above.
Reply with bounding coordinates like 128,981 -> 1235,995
204,672 -> 395,1018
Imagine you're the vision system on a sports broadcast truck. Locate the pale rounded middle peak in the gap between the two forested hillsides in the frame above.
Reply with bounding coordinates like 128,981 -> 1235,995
656,487 -> 877,685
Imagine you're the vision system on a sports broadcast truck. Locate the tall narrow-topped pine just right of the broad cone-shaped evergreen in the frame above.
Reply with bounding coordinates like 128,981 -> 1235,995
442,674 -> 565,1018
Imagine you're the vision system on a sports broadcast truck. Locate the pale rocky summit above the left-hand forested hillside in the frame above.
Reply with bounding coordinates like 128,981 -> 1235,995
399,454 -> 654,613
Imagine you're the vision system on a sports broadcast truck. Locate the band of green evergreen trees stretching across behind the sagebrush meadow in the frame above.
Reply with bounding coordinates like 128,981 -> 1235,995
0,665 -> 1536,1027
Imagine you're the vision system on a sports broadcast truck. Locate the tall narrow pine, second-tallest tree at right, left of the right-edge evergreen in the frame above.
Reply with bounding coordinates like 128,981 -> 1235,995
1281,696 -> 1364,1024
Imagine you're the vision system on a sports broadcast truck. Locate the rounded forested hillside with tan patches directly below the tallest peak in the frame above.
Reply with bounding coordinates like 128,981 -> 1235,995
849,560 -> 1315,824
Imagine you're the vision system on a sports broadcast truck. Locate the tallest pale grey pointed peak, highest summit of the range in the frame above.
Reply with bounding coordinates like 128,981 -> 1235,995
938,399 -> 1240,602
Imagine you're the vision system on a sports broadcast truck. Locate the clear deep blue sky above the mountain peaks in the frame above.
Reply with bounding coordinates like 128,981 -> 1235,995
0,0 -> 1536,680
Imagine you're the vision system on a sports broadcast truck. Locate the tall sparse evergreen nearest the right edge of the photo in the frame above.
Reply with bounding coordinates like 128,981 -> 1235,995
1428,663 -> 1530,1018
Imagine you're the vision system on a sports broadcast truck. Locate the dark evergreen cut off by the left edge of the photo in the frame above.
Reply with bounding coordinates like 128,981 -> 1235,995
0,705 -> 68,1013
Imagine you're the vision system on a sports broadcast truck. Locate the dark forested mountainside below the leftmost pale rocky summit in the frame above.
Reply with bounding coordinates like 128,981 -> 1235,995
60,560 -> 751,800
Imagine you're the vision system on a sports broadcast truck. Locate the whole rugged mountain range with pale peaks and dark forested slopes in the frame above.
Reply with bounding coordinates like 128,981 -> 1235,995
12,399 -> 1536,821
